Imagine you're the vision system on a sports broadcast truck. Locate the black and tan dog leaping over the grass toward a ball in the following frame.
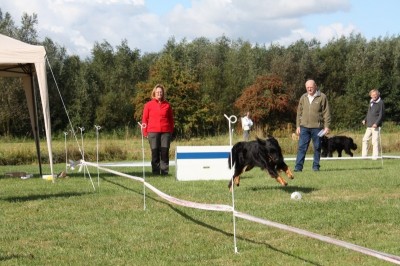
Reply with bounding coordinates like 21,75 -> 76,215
228,136 -> 294,191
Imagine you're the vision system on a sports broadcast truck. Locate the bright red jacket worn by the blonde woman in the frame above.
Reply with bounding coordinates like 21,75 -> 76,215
142,99 -> 174,137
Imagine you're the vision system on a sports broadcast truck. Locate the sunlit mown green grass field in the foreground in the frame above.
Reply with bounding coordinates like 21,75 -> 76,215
0,159 -> 400,265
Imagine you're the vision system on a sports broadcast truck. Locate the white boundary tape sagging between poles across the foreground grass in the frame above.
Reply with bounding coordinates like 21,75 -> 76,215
82,161 -> 400,265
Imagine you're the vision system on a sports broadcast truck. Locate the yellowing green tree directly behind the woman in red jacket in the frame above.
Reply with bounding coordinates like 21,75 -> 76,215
133,53 -> 215,138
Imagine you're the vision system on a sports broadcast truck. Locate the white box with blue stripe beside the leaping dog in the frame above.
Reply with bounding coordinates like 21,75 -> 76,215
175,146 -> 232,181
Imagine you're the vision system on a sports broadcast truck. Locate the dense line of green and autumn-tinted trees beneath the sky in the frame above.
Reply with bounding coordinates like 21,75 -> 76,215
0,9 -> 400,138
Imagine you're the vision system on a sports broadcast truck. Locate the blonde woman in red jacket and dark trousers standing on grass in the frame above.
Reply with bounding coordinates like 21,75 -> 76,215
142,84 -> 174,175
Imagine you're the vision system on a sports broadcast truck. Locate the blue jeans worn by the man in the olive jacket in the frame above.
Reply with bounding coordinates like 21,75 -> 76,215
294,127 -> 321,171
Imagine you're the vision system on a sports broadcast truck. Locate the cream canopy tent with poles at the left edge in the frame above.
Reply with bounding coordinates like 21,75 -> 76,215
0,34 -> 54,179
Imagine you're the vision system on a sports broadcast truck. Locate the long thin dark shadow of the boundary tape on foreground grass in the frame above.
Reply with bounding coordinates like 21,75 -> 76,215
168,204 -> 321,265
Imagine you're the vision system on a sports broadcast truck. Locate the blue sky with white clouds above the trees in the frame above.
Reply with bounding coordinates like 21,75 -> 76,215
0,0 -> 400,57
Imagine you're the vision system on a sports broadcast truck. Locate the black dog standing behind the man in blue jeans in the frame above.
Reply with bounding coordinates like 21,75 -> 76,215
321,136 -> 357,157
